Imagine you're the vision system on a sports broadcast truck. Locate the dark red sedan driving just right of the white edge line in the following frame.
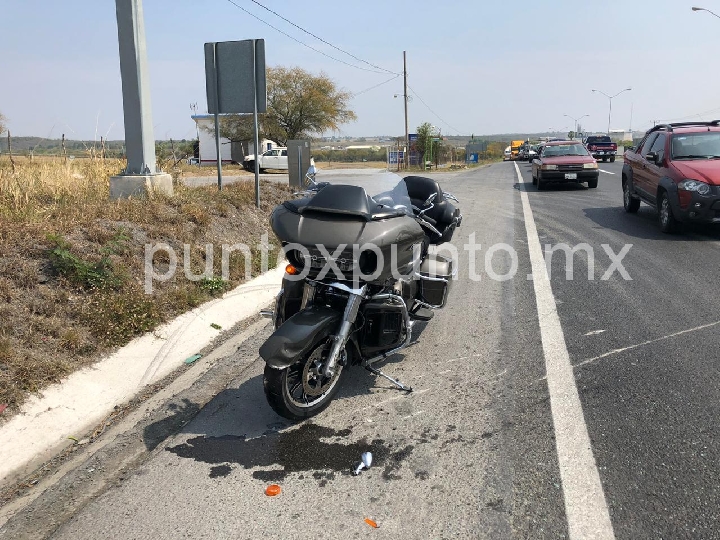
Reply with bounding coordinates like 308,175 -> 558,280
532,141 -> 600,190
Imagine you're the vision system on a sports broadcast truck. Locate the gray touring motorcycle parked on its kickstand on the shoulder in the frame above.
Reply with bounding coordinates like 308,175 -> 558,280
260,172 -> 462,420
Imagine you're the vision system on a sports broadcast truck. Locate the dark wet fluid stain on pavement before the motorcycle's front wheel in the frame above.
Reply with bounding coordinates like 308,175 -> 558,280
166,424 -> 414,485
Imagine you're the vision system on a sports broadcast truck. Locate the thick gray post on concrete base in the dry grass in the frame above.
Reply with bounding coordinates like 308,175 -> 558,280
110,0 -> 172,198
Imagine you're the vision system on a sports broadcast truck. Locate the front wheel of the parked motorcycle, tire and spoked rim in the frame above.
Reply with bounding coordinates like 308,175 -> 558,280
263,338 -> 347,421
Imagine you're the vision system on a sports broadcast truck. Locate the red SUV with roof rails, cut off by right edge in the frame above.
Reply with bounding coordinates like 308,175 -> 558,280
622,120 -> 720,233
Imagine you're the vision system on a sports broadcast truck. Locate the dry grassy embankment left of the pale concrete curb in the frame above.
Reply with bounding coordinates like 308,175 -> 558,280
0,154 -> 290,417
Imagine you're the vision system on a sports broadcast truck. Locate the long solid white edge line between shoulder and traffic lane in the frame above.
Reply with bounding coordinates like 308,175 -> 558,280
515,164 -> 615,540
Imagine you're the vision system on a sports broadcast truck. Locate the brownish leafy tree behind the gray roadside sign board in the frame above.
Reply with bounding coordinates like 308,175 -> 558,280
211,67 -> 357,146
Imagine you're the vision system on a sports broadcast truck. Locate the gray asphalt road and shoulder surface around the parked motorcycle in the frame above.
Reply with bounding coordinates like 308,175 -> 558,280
5,162 -> 720,539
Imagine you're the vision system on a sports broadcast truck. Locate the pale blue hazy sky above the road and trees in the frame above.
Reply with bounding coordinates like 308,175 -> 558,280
0,0 -> 720,140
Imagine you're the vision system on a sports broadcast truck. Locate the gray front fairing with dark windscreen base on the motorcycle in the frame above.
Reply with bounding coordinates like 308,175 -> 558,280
270,185 -> 425,283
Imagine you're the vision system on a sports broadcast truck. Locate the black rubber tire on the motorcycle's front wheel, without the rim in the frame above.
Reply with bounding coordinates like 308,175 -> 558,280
263,338 -> 346,421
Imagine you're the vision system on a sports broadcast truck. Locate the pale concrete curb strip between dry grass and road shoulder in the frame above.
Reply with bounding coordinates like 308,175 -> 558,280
0,262 -> 285,485
